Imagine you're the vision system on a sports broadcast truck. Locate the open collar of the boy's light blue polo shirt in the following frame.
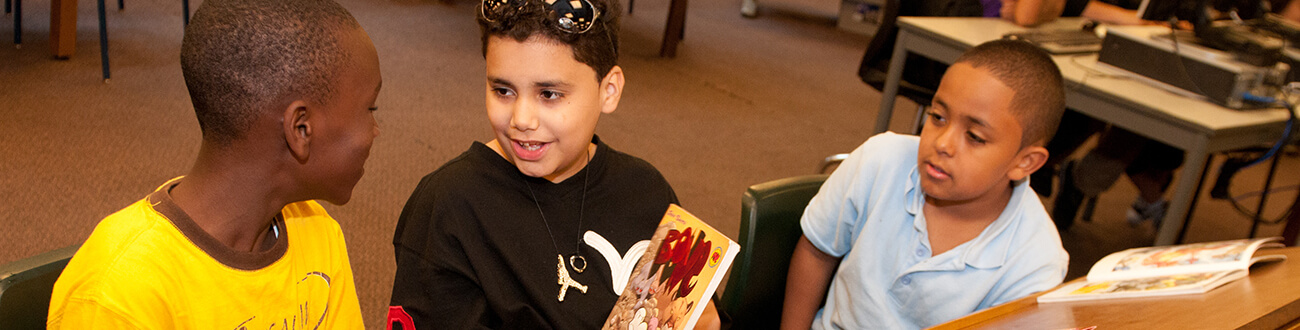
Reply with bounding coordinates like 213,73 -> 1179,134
904,166 -> 1030,269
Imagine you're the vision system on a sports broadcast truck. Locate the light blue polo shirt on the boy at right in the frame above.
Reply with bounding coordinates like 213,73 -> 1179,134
801,133 -> 1070,329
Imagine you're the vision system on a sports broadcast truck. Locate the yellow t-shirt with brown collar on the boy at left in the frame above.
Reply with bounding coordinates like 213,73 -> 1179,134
47,181 -> 363,329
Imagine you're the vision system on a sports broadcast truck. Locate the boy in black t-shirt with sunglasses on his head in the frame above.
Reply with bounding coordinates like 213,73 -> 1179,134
389,0 -> 716,329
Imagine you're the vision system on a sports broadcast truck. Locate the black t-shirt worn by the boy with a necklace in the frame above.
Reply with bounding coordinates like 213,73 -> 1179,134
390,138 -> 677,329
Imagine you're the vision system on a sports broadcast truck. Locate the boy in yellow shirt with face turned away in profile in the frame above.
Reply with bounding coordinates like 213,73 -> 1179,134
47,0 -> 381,329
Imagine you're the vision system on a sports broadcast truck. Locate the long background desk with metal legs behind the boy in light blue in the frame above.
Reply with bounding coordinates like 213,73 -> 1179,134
875,17 -> 1287,246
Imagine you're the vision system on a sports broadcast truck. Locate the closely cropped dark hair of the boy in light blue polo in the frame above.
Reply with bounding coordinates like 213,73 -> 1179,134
954,39 -> 1065,148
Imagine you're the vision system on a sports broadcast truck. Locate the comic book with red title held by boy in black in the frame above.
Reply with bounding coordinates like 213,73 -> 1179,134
603,205 -> 740,330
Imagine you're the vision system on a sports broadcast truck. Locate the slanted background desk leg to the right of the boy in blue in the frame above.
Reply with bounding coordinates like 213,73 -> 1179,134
1156,142 -> 1209,246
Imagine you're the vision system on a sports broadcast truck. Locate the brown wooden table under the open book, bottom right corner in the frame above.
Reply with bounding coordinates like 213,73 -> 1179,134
932,247 -> 1300,330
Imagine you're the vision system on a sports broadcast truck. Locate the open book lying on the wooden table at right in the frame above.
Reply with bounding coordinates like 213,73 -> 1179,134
1039,238 -> 1286,303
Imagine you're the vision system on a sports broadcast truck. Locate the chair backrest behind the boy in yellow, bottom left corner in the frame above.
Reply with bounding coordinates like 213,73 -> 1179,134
0,244 -> 81,330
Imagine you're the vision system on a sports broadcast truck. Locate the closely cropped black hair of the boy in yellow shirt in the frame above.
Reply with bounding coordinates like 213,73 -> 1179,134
181,0 -> 360,146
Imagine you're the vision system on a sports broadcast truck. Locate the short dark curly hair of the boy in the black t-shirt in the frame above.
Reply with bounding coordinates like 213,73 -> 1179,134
475,0 -> 623,82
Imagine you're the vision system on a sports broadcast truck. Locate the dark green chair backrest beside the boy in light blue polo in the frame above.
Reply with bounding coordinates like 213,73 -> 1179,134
718,175 -> 828,329
